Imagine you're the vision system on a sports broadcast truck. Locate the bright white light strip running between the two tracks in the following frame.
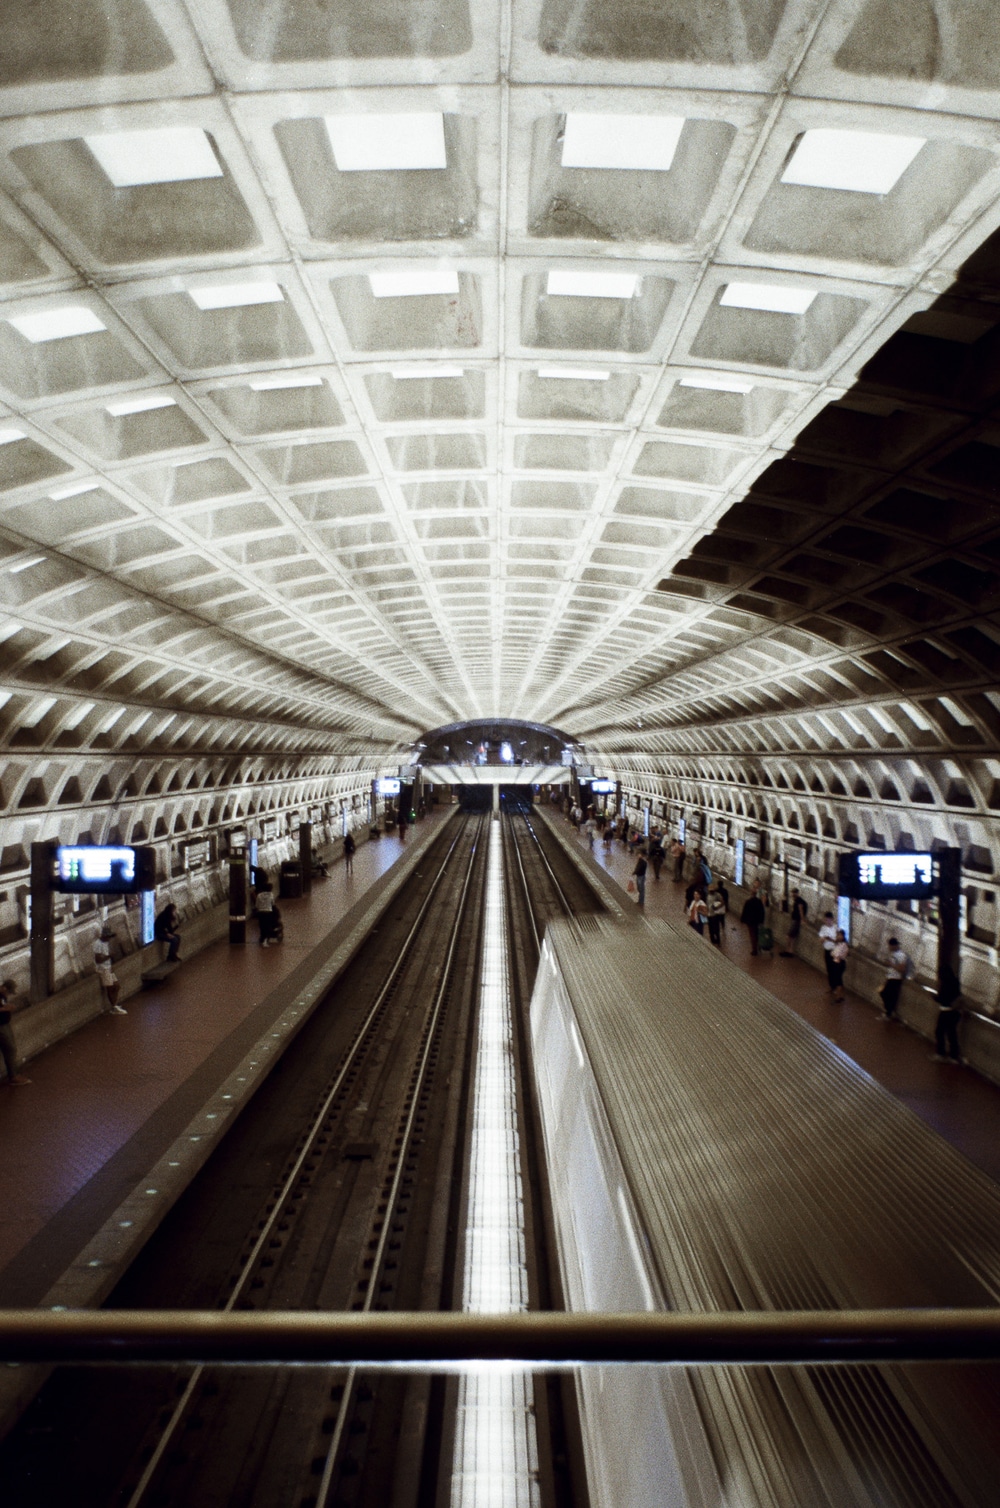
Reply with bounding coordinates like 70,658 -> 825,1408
451,822 -> 540,1508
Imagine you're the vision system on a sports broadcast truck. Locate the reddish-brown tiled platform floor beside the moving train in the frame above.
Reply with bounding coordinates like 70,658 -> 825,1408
541,807 -> 1000,1182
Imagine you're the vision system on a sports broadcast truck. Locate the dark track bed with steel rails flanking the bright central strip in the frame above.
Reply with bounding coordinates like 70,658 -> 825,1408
0,817 -> 609,1508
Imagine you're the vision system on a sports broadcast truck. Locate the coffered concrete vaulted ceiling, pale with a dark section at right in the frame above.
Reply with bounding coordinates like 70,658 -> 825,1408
0,0 -> 1000,772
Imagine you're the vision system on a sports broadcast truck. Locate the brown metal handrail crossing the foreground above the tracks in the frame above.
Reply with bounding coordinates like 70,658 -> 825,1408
7,1309 -> 1000,1371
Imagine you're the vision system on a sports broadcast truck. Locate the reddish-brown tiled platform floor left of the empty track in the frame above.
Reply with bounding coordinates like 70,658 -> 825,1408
0,807 -> 456,1306
